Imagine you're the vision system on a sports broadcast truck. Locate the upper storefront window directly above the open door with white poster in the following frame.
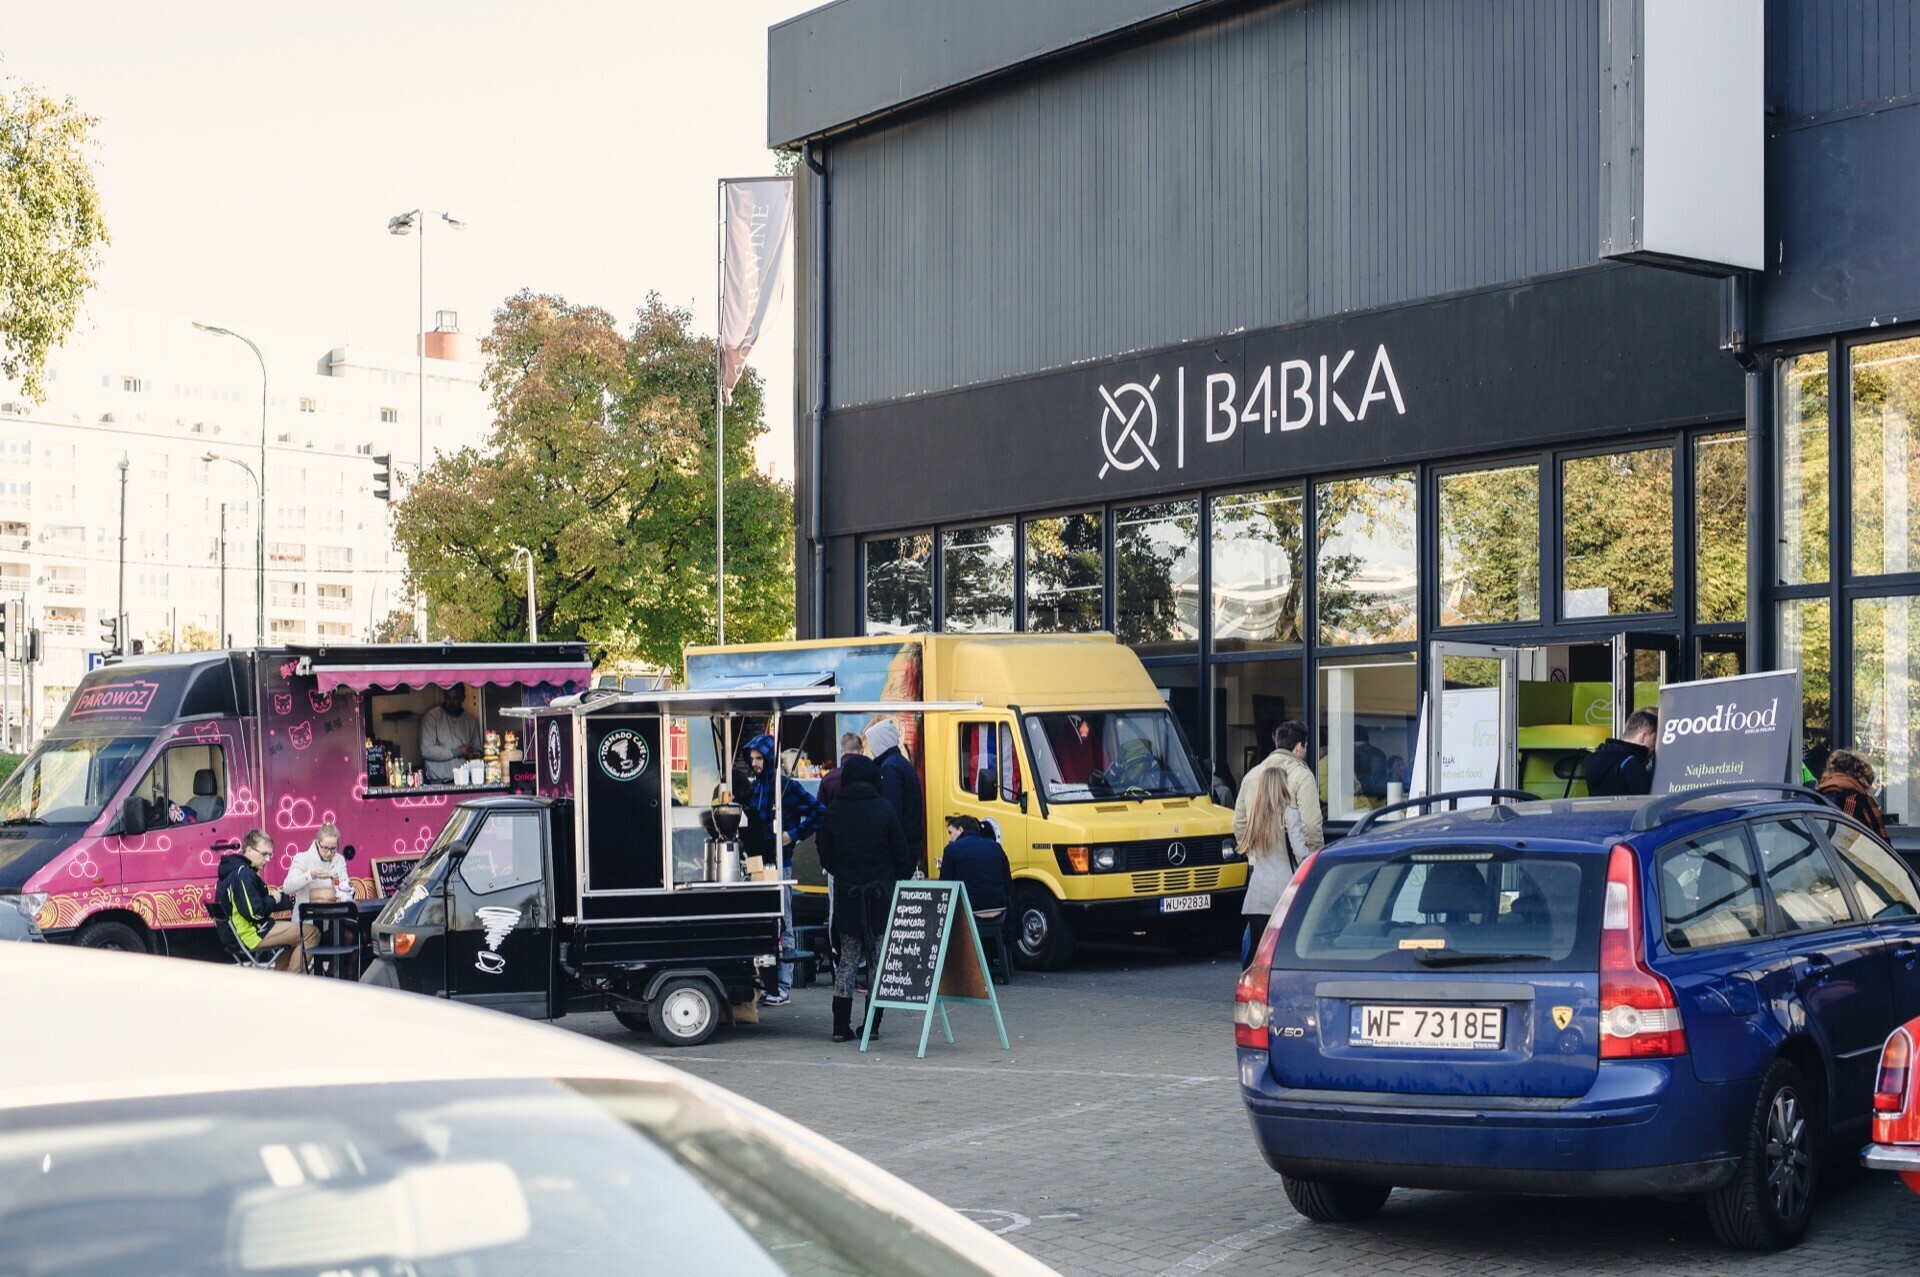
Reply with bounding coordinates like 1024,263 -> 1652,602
1440,465 -> 1540,626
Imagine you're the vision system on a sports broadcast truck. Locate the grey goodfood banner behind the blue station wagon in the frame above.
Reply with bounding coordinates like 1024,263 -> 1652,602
1653,670 -> 1801,793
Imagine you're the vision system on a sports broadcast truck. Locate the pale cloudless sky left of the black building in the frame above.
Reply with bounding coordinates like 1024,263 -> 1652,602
0,0 -> 818,480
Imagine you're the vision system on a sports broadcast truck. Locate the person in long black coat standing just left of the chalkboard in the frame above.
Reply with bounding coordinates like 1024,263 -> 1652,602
814,755 -> 914,1043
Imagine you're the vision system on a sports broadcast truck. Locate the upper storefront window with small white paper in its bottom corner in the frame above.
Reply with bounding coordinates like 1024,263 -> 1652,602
1561,447 -> 1674,618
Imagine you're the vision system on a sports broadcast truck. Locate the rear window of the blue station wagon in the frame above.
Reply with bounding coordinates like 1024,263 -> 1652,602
1273,847 -> 1607,972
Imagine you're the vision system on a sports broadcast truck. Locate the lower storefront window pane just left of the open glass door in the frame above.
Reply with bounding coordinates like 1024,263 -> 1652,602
1313,653 -> 1419,820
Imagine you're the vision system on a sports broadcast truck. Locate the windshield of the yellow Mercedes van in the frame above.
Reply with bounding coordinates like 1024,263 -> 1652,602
1025,709 -> 1202,803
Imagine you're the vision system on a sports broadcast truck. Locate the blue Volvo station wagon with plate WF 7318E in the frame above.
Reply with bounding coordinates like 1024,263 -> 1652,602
1235,787 -> 1920,1250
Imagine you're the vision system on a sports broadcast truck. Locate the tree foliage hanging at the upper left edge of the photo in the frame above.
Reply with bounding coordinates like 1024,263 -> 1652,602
0,65 -> 108,403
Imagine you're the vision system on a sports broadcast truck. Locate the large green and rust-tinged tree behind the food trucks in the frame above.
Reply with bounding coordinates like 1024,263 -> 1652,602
394,292 -> 793,670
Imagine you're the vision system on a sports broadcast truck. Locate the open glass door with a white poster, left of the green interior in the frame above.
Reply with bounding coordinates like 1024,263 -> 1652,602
1415,641 -> 1519,793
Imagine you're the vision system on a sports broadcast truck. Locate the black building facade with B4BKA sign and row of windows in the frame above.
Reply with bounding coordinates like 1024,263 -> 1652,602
770,0 -> 1920,833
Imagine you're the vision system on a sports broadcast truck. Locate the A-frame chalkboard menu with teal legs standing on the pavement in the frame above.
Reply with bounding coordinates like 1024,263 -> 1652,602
860,881 -> 1008,1056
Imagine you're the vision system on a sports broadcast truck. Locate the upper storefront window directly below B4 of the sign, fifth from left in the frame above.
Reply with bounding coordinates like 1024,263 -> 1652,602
1213,484 -> 1308,651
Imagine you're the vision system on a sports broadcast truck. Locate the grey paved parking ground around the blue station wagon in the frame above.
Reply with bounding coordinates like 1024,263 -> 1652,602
561,949 -> 1920,1277
